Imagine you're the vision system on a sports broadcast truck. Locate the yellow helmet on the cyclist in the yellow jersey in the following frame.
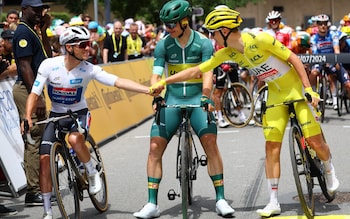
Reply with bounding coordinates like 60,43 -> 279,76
204,7 -> 243,31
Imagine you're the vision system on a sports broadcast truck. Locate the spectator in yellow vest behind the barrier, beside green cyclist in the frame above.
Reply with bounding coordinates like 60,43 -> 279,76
126,23 -> 149,60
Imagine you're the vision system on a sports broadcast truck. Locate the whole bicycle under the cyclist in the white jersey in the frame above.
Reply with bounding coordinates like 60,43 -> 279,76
24,110 -> 108,219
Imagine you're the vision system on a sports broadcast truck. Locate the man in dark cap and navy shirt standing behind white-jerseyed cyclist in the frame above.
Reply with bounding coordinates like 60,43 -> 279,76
13,0 -> 52,206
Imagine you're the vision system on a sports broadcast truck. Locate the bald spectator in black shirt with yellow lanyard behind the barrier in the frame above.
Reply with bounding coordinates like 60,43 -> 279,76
102,21 -> 128,64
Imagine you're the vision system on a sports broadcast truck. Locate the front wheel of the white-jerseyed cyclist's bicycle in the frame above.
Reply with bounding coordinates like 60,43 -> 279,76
50,142 -> 80,219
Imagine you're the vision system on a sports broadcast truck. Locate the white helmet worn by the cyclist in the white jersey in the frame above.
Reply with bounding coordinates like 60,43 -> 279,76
60,26 -> 90,45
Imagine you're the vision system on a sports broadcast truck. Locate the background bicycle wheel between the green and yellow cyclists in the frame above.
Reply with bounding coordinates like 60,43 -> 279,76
221,82 -> 254,128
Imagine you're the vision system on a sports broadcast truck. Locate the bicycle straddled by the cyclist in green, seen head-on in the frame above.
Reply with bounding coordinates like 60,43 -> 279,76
155,102 -> 211,219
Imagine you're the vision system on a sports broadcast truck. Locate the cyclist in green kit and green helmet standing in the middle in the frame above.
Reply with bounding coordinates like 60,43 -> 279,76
134,0 -> 234,218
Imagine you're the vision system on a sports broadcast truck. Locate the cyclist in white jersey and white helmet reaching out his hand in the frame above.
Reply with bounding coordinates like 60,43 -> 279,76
21,26 -> 160,219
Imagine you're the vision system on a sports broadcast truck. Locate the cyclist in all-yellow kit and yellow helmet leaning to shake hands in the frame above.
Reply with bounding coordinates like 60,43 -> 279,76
153,6 -> 339,217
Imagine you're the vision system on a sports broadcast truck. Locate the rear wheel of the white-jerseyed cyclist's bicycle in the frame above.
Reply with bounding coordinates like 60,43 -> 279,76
86,135 -> 108,212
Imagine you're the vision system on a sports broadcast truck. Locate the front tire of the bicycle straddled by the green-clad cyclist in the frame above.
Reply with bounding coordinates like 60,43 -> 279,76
180,132 -> 190,219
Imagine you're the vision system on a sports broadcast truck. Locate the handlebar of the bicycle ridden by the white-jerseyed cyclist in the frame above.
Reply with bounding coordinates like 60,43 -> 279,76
23,110 -> 85,144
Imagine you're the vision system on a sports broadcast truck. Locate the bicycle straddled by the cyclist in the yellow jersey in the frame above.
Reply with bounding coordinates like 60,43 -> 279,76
266,94 -> 335,219
